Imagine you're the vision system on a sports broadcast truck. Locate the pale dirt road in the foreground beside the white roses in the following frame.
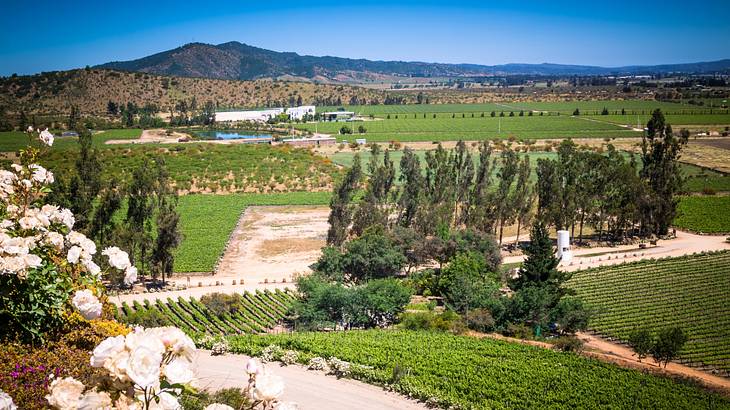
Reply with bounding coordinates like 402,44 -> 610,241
194,350 -> 427,410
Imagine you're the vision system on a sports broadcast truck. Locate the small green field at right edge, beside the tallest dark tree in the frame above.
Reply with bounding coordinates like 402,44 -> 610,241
674,195 -> 730,234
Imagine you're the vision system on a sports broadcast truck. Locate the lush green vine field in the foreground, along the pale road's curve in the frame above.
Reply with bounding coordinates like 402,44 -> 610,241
223,330 -> 730,409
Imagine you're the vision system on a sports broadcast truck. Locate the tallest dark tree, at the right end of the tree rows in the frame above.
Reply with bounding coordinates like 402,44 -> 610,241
640,109 -> 689,235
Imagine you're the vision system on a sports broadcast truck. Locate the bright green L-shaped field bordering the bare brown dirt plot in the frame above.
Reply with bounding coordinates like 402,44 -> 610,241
174,192 -> 330,272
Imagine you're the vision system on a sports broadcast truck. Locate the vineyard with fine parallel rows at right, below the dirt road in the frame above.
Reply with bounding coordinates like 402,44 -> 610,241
568,252 -> 730,375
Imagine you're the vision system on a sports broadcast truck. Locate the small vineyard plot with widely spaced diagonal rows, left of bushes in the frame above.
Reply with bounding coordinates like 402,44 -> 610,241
118,289 -> 295,335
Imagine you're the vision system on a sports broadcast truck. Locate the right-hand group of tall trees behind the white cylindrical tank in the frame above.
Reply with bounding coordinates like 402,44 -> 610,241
537,110 -> 689,240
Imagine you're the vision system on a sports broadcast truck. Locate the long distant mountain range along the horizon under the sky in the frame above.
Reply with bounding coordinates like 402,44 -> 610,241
97,41 -> 730,82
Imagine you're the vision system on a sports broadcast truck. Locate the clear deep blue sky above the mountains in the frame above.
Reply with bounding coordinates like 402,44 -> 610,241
0,0 -> 730,75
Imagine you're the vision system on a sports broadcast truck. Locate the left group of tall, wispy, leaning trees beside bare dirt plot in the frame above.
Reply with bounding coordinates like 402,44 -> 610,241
328,141 -> 534,246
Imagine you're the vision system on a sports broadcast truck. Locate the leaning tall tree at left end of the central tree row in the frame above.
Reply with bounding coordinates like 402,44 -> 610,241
327,154 -> 362,243
